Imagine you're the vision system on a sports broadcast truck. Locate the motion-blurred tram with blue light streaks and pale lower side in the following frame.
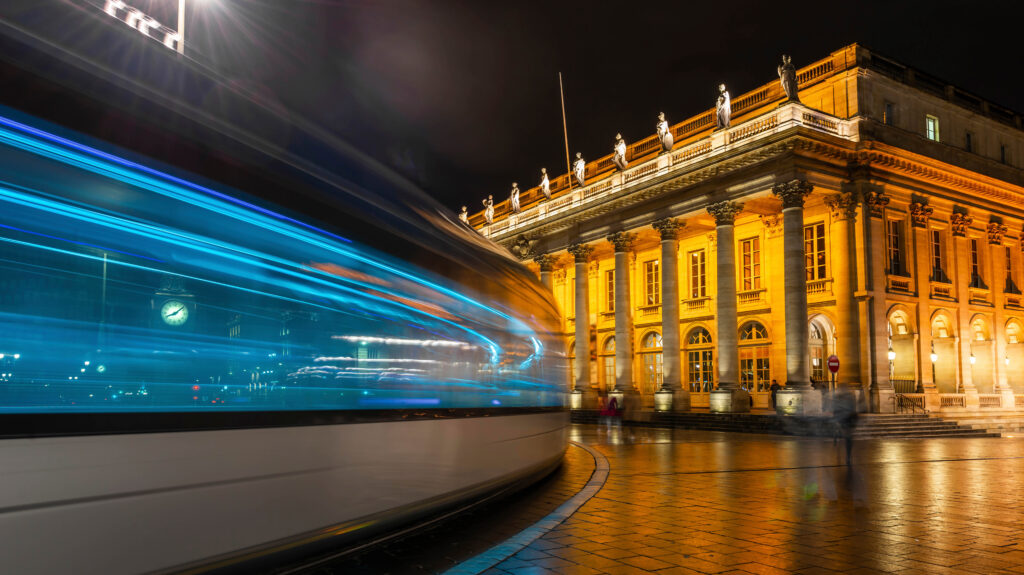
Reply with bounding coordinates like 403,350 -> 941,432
0,10 -> 568,574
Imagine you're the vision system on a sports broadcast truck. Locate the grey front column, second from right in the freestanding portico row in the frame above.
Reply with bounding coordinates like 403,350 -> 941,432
708,202 -> 751,412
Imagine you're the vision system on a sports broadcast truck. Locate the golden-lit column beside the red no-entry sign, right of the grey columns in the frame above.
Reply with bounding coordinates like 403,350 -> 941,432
827,191 -> 861,399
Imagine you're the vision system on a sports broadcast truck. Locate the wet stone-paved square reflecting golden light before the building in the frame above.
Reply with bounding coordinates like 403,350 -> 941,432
487,426 -> 1024,575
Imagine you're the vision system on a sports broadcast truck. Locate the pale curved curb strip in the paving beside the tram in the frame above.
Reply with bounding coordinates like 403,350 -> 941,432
444,441 -> 610,575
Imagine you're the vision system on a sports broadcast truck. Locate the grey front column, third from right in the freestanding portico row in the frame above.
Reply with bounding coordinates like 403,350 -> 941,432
653,218 -> 690,411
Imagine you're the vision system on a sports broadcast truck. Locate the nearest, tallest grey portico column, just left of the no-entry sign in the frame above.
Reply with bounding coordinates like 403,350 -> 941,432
772,180 -> 821,413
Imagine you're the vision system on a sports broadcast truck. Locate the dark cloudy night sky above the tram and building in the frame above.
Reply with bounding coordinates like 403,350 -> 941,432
8,0 -> 1024,211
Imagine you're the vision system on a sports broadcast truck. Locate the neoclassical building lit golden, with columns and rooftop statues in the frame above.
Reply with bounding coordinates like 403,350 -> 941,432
469,45 -> 1024,413
